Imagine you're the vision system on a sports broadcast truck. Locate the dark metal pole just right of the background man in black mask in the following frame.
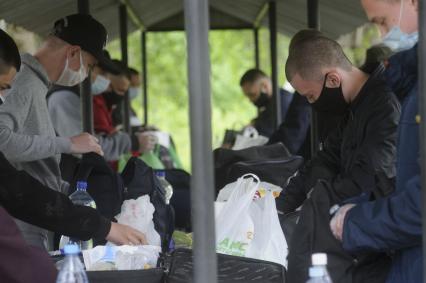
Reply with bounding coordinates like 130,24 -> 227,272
269,0 -> 282,128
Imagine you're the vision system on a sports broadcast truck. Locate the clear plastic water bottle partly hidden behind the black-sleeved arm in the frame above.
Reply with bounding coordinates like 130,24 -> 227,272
59,182 -> 96,250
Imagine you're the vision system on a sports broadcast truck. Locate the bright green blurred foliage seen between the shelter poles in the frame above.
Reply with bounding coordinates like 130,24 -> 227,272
108,30 -> 288,170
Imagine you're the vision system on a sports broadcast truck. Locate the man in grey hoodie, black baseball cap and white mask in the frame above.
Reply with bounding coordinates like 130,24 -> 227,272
0,15 -> 115,247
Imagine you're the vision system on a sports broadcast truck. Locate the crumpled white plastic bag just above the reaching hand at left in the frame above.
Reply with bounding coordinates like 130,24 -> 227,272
115,195 -> 161,246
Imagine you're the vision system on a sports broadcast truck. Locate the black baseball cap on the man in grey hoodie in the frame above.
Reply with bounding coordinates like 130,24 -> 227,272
51,14 -> 117,73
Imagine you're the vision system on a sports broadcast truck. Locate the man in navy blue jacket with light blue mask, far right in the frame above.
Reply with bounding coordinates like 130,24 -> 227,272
330,0 -> 424,283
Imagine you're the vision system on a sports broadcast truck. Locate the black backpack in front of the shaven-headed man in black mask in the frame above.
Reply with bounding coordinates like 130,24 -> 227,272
287,180 -> 391,283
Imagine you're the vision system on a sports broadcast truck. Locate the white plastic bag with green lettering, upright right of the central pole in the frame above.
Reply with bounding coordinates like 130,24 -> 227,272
216,174 -> 288,266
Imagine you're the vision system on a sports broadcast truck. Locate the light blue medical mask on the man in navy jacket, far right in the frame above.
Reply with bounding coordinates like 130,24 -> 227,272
383,0 -> 419,52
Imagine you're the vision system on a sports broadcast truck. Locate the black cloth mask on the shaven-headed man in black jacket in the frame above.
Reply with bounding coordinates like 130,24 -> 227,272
311,74 -> 349,114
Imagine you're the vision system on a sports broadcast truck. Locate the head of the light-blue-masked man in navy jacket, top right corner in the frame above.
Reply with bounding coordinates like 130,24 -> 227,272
361,0 -> 418,52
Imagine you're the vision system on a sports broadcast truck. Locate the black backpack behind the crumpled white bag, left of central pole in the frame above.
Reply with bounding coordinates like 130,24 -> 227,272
121,157 -> 175,251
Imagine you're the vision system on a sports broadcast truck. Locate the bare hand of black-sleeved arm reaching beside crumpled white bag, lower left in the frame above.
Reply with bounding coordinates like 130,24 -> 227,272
106,222 -> 148,245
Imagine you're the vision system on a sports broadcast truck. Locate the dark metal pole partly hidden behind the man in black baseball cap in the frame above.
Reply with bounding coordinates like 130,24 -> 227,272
77,0 -> 94,134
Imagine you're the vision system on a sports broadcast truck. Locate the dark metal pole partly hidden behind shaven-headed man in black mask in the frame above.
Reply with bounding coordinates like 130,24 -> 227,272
307,0 -> 320,156
